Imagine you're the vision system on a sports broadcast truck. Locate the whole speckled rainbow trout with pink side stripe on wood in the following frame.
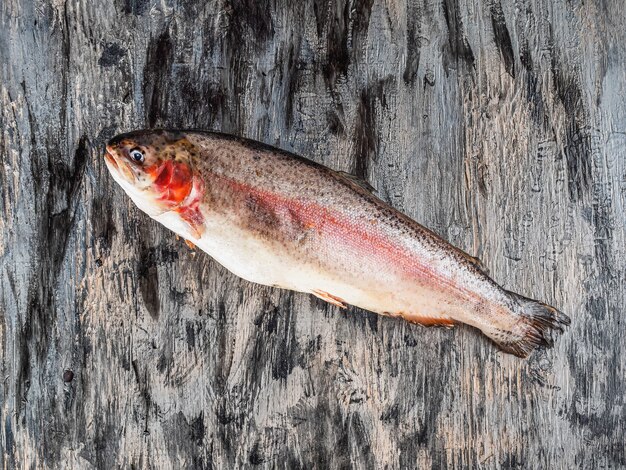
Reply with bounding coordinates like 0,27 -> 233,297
104,129 -> 570,358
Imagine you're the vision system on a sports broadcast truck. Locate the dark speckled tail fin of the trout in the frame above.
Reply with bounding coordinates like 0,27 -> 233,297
490,292 -> 570,357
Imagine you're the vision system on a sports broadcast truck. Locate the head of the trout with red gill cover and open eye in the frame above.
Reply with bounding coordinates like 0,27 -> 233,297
105,130 -> 197,216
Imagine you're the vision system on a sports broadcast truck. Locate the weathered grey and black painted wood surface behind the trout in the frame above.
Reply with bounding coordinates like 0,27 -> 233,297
0,0 -> 626,469
